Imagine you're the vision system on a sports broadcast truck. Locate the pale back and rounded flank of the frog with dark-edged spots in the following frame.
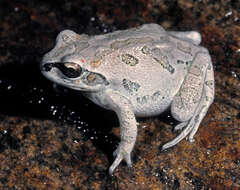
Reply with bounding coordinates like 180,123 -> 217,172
84,24 -> 204,116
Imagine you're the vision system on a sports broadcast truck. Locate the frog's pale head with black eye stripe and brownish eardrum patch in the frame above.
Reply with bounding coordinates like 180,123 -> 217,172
41,30 -> 108,91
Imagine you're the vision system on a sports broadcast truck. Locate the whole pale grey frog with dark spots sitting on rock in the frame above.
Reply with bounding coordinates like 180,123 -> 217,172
41,24 -> 214,174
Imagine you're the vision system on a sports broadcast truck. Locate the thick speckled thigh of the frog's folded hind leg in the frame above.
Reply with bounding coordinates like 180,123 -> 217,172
171,53 -> 207,122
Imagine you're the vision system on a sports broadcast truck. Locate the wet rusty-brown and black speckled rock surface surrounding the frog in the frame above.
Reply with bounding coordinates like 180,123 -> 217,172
0,0 -> 240,190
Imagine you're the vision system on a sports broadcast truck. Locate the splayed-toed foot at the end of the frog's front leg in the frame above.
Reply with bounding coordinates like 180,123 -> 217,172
109,143 -> 132,175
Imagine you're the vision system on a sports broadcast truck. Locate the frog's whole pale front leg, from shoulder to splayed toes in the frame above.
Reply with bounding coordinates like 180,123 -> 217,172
105,89 -> 137,175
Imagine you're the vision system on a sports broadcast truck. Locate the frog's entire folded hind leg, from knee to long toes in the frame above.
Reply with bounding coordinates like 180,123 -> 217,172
162,53 -> 214,150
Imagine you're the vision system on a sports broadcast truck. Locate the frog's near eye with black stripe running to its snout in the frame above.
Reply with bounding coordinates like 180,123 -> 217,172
41,62 -> 82,78
